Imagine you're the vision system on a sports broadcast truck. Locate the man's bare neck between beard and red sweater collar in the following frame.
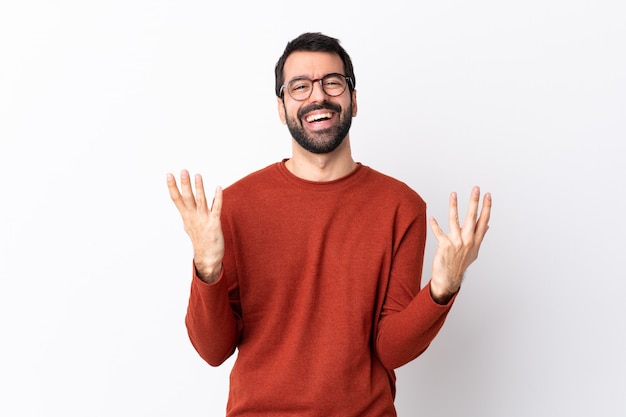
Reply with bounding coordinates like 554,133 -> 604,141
285,137 -> 356,182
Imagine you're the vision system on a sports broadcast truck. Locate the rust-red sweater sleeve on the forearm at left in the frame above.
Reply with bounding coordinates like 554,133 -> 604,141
185,267 -> 242,366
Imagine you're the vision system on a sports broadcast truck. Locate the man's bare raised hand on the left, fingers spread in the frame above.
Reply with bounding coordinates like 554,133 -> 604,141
167,170 -> 224,283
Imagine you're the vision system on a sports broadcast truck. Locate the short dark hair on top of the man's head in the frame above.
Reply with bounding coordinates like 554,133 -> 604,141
274,32 -> 356,97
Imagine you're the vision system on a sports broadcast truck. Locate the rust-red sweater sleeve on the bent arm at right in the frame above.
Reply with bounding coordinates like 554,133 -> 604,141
376,203 -> 456,369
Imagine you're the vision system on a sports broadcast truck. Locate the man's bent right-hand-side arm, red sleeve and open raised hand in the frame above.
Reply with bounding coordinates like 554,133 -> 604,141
376,187 -> 491,369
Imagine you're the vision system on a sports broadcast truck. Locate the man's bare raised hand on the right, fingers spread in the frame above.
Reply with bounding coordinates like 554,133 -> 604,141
430,187 -> 491,304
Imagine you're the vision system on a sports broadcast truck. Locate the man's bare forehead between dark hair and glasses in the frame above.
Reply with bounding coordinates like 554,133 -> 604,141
283,51 -> 344,80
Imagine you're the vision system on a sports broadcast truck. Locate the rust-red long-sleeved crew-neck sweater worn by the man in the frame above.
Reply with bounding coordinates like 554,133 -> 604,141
186,161 -> 452,417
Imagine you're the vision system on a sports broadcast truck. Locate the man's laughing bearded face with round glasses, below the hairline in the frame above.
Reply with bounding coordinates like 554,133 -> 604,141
278,51 -> 357,154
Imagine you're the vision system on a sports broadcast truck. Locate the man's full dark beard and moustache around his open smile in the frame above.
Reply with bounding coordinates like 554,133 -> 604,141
285,101 -> 352,154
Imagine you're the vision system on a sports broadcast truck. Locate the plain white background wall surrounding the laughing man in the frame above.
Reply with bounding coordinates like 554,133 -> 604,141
0,0 -> 626,417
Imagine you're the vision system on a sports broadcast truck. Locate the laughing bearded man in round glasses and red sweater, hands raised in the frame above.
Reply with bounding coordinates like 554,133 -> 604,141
167,33 -> 491,417
